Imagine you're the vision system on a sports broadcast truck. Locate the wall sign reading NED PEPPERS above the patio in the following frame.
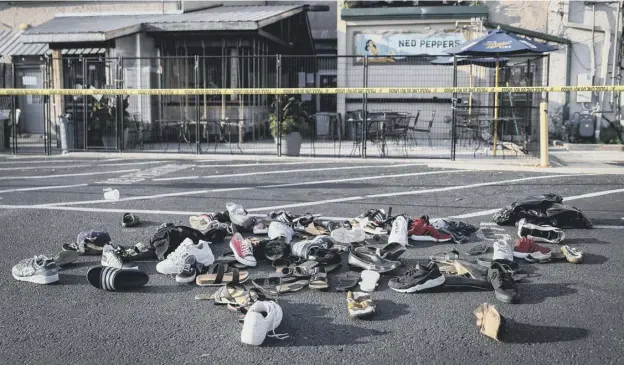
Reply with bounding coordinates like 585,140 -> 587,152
353,30 -> 466,63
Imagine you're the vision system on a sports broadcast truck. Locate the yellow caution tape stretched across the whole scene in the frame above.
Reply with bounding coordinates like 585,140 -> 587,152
0,85 -> 624,96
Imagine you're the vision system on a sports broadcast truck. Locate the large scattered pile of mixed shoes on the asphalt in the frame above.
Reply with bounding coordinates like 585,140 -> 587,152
13,194 -> 588,345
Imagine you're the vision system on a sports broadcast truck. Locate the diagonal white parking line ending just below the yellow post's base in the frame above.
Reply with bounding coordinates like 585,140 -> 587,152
247,175 -> 575,212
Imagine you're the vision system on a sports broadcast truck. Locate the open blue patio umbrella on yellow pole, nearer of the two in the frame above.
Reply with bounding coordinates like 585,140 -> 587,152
444,27 -> 558,156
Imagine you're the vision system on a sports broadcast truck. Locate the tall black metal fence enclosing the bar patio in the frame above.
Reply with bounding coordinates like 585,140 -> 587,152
0,55 -> 548,159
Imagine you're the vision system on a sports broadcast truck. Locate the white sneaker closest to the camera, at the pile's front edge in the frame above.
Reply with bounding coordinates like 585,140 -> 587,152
241,301 -> 288,346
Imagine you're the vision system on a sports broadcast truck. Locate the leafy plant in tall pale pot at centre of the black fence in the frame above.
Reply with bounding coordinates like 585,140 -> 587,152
269,96 -> 310,156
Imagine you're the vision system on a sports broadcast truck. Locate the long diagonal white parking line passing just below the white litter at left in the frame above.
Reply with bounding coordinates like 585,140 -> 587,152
35,170 -> 464,206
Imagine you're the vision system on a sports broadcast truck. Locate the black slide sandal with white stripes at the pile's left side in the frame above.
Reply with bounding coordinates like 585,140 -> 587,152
87,266 -> 149,291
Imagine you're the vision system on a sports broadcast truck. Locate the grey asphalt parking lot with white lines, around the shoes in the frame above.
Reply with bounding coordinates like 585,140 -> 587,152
0,156 -> 624,364
